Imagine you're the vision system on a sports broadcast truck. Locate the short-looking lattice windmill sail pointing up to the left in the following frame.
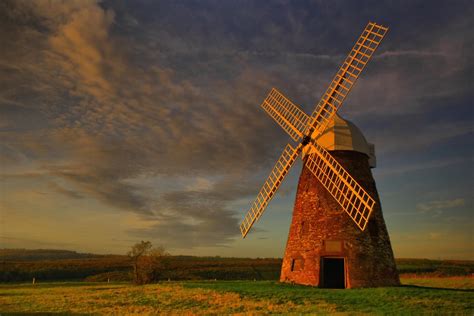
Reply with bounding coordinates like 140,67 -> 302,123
262,88 -> 309,141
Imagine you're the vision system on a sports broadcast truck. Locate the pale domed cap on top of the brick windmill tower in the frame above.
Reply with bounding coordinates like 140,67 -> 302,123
317,114 -> 377,168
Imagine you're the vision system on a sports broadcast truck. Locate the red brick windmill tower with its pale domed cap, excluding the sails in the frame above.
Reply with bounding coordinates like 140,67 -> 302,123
280,115 -> 400,288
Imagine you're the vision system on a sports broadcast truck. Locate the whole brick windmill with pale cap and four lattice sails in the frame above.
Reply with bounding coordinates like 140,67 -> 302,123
240,22 -> 399,288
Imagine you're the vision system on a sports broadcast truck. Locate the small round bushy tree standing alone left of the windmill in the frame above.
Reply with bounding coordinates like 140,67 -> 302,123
128,240 -> 168,284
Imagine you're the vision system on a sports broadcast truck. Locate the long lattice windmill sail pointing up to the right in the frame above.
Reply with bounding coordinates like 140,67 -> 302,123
307,22 -> 388,134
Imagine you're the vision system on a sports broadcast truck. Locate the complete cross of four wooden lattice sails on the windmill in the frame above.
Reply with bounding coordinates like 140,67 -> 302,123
240,22 -> 388,237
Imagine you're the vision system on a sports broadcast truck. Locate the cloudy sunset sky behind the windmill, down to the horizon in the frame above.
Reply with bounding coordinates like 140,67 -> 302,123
0,0 -> 474,259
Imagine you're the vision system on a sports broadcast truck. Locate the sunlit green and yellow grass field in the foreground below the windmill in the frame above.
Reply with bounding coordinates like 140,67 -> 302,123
0,277 -> 474,315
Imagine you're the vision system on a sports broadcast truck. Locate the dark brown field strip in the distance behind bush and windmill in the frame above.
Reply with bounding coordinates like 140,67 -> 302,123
0,249 -> 474,282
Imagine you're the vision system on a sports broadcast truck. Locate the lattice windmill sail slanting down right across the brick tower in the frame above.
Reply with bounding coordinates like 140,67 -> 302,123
306,143 -> 375,230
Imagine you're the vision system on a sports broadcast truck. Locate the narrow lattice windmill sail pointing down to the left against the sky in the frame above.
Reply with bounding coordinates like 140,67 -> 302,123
240,144 -> 300,237
